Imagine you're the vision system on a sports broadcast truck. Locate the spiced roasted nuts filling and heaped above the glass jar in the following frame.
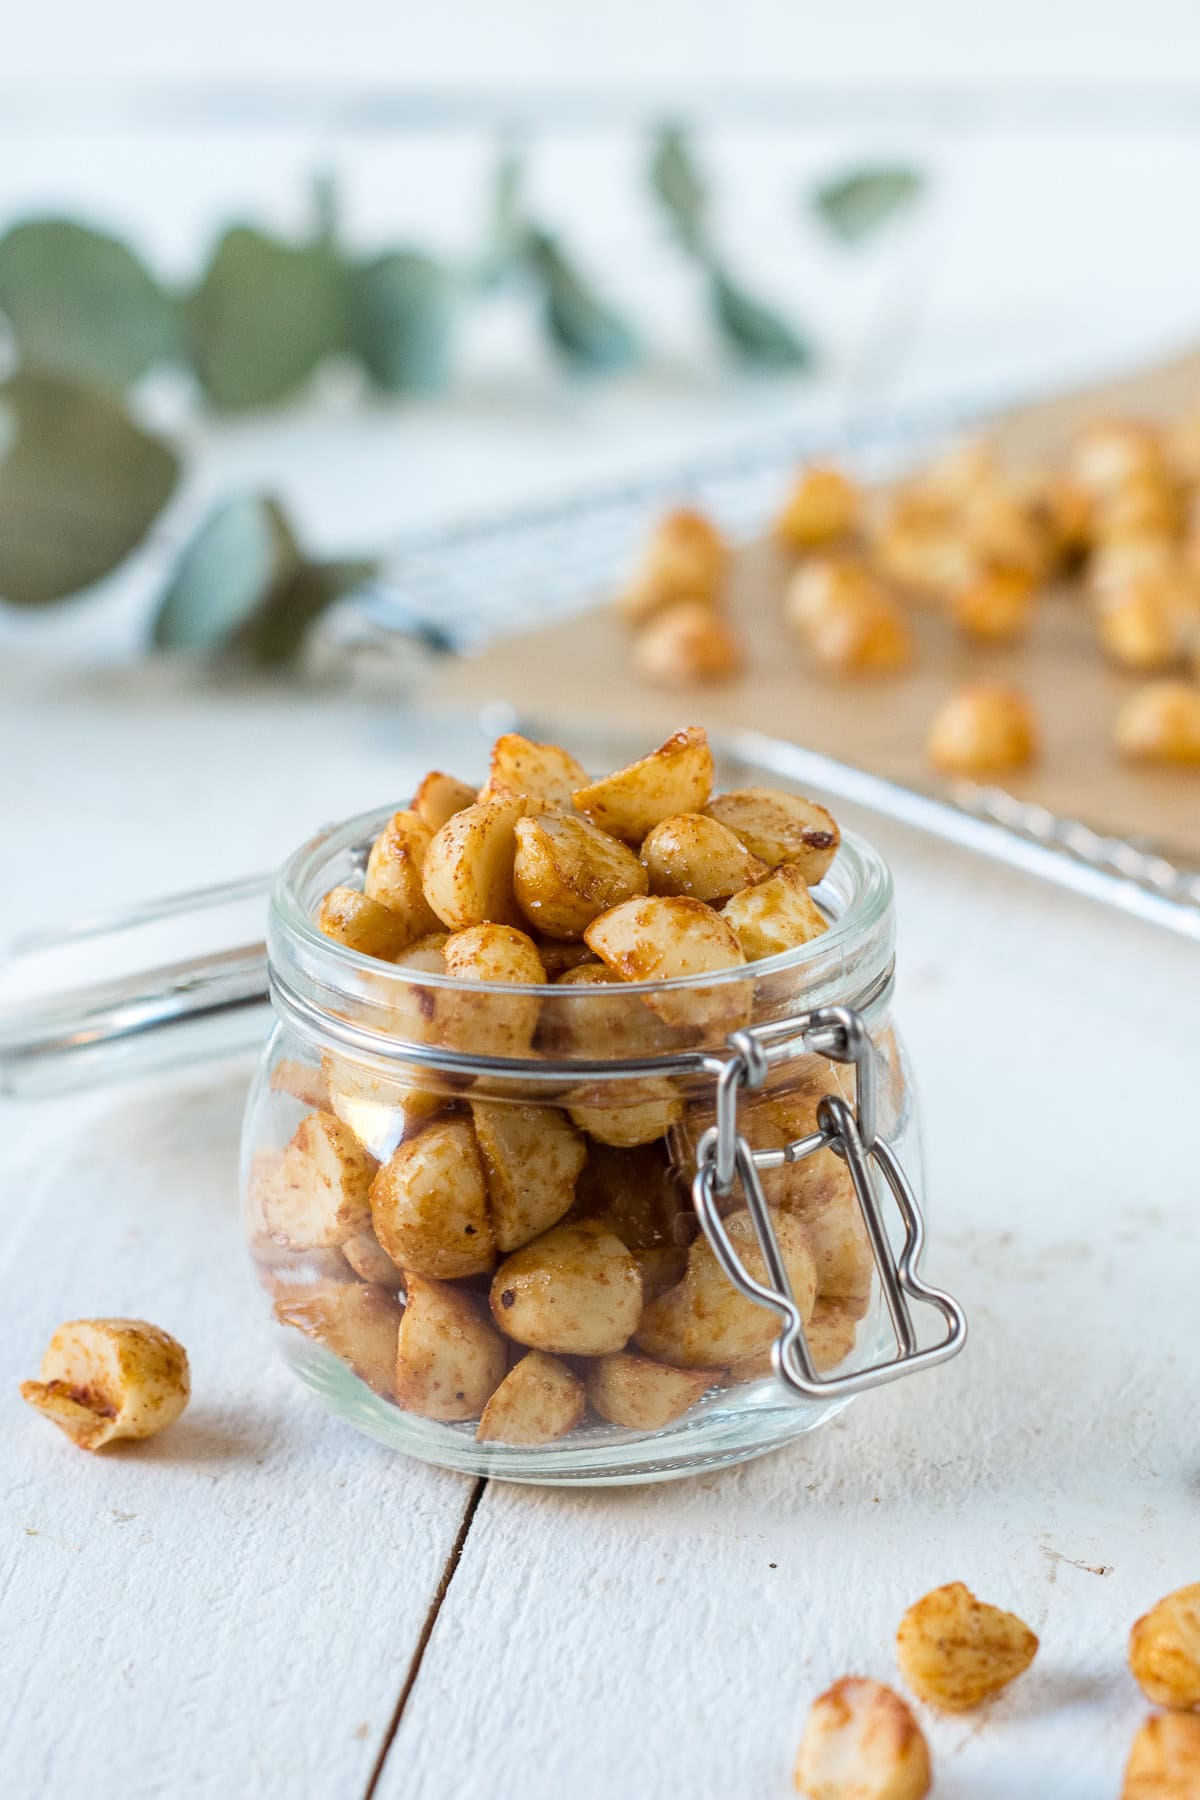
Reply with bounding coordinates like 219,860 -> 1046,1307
248,727 -> 874,1445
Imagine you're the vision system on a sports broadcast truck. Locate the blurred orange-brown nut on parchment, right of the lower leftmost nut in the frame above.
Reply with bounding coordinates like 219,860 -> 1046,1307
784,558 -> 912,675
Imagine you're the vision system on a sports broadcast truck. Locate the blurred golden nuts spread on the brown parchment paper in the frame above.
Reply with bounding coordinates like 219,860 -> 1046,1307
617,412 -> 1200,776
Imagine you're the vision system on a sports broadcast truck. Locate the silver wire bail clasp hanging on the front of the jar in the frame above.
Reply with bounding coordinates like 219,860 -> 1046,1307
693,1006 -> 966,1400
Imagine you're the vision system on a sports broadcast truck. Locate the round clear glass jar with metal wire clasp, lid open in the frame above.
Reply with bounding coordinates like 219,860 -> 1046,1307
243,812 -> 964,1483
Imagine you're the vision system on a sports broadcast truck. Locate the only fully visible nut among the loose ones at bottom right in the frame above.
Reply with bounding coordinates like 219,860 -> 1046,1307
896,1580 -> 1038,1712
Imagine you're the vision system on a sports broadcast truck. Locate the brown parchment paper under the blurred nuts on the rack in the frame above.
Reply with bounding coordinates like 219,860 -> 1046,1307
430,353 -> 1200,862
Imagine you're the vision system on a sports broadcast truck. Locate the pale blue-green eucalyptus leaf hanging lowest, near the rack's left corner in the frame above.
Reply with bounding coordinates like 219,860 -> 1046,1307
151,493 -> 304,653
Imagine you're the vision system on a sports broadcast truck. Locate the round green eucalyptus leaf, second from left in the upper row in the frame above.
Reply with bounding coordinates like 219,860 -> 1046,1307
189,225 -> 345,410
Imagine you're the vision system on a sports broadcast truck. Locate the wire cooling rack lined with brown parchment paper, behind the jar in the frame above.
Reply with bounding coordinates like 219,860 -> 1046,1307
349,355 -> 1200,938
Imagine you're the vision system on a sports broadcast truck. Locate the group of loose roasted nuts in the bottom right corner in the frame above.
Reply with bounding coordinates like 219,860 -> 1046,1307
795,1582 -> 1200,1800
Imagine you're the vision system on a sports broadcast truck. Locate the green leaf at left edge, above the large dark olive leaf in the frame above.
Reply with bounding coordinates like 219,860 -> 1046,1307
0,220 -> 175,389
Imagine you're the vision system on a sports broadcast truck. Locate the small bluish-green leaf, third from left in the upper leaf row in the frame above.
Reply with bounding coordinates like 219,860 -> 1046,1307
349,250 -> 453,394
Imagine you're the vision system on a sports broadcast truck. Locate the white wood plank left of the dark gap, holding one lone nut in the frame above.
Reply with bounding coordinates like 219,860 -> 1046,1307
0,1067 -> 471,1800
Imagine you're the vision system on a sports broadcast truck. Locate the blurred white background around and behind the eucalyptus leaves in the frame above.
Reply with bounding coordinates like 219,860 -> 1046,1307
0,0 -> 1200,655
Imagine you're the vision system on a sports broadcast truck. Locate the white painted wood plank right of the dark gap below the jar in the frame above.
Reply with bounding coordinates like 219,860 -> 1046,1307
380,813 -> 1200,1800
